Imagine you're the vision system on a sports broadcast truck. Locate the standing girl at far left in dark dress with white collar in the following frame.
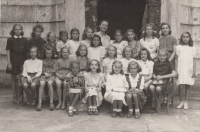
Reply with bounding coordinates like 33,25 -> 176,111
6,24 -> 28,103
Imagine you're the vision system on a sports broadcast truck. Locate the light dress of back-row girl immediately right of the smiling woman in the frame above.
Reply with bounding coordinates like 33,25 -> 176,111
110,41 -> 128,59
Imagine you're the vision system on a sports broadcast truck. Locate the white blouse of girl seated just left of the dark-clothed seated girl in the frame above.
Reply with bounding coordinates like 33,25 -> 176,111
137,60 -> 154,75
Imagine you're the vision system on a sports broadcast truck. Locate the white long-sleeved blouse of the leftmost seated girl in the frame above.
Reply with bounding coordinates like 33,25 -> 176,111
22,58 -> 42,77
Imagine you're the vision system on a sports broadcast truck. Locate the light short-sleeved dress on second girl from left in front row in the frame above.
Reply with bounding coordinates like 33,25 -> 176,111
82,72 -> 104,107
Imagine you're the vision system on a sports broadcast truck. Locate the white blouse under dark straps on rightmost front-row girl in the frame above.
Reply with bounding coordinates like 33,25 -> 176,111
129,74 -> 144,90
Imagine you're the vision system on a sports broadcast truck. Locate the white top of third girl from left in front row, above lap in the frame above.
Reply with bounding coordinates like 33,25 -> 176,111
106,74 -> 129,91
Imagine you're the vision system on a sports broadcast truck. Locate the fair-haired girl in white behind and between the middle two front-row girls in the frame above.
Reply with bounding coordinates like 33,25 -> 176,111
102,45 -> 117,76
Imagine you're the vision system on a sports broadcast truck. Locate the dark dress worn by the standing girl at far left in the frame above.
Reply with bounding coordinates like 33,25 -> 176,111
6,37 -> 28,75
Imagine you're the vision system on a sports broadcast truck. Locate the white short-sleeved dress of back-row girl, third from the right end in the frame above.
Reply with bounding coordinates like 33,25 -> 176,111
140,38 -> 159,58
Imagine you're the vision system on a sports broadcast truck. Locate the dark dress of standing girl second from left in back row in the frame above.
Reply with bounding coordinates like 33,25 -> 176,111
28,38 -> 46,59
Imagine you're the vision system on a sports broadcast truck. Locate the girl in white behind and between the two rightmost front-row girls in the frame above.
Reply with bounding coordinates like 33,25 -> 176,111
120,46 -> 136,74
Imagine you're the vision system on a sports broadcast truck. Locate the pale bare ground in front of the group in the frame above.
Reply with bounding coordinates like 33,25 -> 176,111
0,78 -> 200,132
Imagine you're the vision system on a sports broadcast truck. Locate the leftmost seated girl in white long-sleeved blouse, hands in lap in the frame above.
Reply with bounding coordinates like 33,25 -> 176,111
22,46 -> 42,106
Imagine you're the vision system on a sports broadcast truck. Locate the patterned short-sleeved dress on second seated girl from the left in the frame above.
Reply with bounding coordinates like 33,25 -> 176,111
40,59 -> 56,82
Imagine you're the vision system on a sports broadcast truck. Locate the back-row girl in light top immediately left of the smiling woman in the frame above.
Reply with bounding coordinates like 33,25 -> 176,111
80,27 -> 94,48
